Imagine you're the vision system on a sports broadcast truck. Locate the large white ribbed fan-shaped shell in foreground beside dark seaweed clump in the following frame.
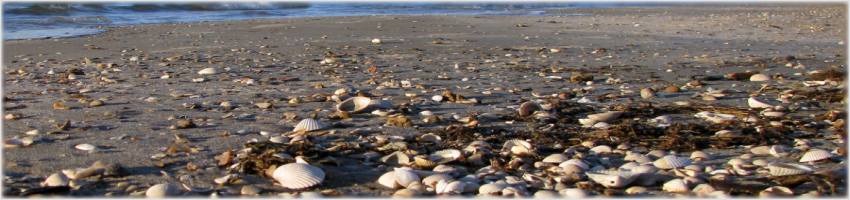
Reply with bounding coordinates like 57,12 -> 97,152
272,163 -> 325,189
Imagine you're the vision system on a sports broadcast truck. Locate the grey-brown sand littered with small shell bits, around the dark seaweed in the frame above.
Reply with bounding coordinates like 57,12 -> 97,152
3,4 -> 847,196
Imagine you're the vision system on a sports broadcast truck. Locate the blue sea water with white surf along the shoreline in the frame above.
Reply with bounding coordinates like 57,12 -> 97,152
3,2 -> 640,40
